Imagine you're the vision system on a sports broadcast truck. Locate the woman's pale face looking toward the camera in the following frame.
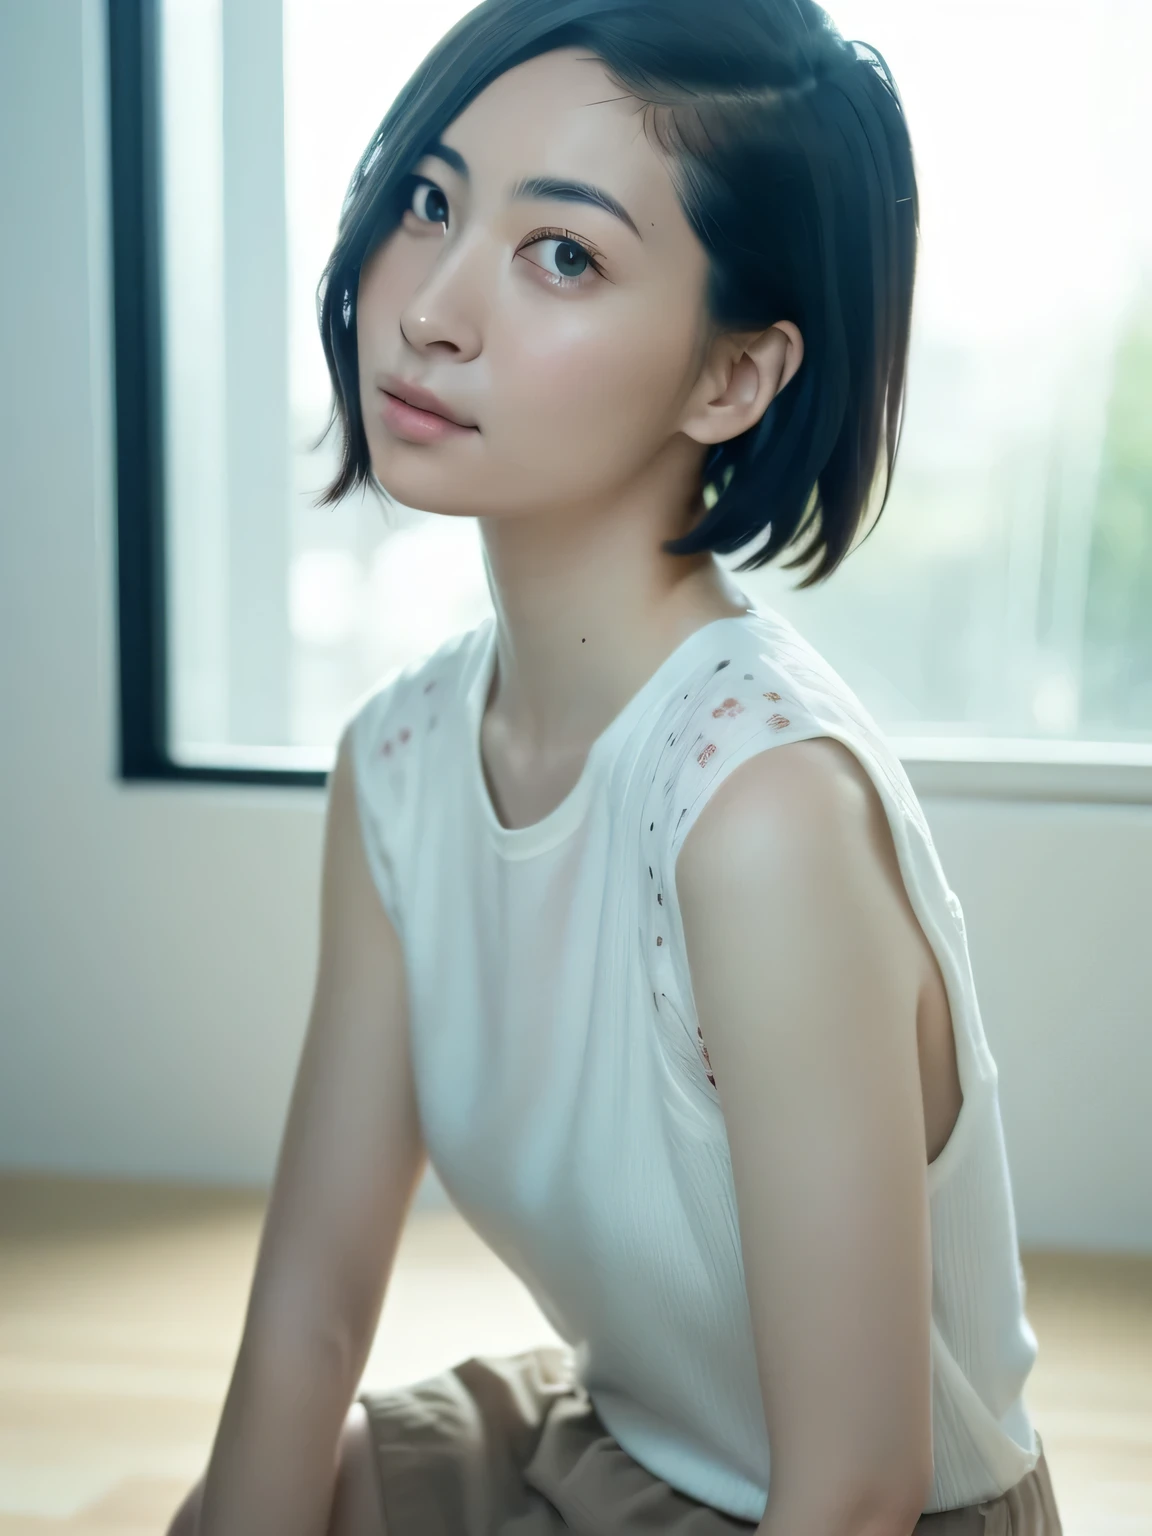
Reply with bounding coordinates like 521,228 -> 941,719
356,48 -> 721,518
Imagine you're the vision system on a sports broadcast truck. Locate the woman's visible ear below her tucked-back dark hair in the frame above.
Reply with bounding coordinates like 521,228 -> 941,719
680,319 -> 803,444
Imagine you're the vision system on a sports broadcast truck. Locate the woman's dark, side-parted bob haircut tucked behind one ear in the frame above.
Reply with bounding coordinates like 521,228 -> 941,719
318,0 -> 920,588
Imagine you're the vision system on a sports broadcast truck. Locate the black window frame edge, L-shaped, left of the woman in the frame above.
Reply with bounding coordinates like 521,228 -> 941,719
106,0 -> 329,788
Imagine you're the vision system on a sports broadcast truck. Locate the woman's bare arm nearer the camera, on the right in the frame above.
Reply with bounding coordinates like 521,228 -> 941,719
677,737 -> 932,1536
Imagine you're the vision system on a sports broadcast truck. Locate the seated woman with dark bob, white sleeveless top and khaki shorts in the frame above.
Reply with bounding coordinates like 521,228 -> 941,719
177,0 -> 1060,1536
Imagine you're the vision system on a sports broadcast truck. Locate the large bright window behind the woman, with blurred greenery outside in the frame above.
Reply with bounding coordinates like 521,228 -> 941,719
109,0 -> 1152,799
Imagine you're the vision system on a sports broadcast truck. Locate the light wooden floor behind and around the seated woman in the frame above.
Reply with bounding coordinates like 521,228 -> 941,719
0,1175 -> 1152,1536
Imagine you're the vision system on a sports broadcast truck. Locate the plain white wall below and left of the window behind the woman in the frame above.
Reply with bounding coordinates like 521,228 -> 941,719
0,0 -> 1152,1252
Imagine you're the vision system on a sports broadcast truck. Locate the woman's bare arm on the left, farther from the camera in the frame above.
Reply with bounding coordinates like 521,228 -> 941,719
172,731 -> 425,1536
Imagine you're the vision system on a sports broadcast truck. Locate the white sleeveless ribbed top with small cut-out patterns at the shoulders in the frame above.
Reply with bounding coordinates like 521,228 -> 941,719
352,607 -> 1038,1521
